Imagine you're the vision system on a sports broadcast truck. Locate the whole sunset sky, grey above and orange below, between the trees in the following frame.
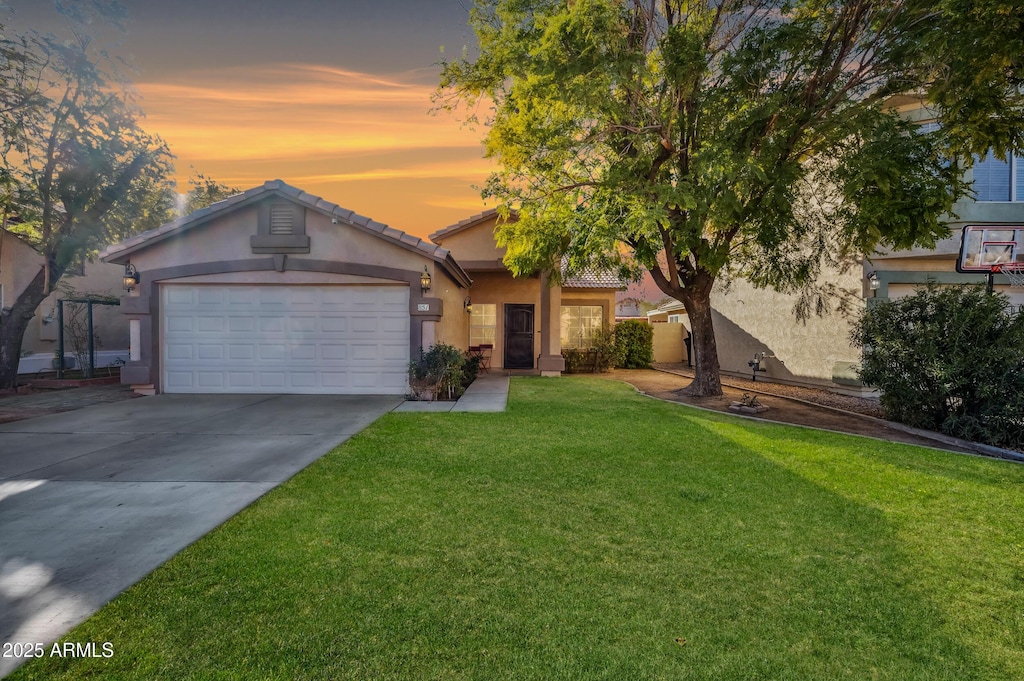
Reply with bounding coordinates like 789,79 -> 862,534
6,0 -> 489,237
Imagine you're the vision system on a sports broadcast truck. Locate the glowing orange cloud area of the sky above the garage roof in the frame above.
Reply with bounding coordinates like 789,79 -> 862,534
136,63 -> 493,235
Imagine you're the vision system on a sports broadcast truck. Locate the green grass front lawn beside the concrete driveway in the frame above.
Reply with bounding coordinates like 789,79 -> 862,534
12,377 -> 1024,680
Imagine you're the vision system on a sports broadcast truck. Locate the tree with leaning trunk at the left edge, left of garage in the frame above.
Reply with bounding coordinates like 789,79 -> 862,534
0,0 -> 173,389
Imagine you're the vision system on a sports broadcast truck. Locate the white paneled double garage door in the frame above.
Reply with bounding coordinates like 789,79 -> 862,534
161,285 -> 410,394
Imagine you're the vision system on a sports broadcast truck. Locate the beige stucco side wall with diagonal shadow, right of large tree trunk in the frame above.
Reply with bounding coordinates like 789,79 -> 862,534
712,267 -> 862,387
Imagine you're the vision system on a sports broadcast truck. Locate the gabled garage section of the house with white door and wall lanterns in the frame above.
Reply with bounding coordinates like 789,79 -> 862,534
100,180 -> 472,395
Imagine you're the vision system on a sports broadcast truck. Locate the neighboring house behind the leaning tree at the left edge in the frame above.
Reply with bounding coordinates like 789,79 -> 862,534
0,229 -> 128,374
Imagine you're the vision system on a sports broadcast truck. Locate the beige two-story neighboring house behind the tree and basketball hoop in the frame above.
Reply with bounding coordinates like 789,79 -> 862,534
648,97 -> 1024,391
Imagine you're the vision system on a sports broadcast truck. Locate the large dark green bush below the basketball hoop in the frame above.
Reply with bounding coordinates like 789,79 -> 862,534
852,285 -> 1024,448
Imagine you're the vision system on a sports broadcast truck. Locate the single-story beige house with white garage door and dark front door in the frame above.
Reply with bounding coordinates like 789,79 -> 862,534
101,180 -> 621,394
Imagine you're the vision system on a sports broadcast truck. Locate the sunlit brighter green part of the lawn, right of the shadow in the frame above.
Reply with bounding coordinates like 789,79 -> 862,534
684,416 -> 1024,679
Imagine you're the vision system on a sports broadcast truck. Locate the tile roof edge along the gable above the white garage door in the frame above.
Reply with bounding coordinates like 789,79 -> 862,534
99,179 -> 461,269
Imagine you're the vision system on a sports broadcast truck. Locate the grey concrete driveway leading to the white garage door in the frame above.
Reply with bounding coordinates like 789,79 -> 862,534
0,395 -> 401,676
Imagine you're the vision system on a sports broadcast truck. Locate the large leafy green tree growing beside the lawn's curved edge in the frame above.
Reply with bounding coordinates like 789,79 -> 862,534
438,0 -> 1019,395
